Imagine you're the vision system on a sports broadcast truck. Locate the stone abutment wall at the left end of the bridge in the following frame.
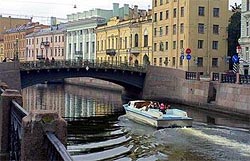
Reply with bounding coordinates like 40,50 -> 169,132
0,62 -> 21,90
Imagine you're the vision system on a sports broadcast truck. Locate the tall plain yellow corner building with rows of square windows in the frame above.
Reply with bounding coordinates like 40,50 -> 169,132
153,0 -> 229,75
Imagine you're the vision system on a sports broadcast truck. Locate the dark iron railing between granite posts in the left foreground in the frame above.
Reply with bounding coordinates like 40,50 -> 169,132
0,87 -> 73,161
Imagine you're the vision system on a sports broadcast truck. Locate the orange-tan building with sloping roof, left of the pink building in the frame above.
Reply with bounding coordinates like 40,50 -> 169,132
3,23 -> 48,61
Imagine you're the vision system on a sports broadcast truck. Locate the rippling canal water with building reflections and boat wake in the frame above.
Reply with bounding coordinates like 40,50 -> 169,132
22,85 -> 250,161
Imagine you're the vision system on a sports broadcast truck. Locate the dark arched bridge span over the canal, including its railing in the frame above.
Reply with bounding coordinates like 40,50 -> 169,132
20,61 -> 146,91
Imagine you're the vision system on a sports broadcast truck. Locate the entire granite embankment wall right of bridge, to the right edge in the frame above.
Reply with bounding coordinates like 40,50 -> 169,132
143,66 -> 250,116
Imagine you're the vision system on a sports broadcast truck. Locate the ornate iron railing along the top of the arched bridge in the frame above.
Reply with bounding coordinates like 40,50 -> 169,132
20,60 -> 146,72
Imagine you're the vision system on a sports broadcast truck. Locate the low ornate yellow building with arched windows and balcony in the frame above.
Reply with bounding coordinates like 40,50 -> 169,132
96,15 -> 152,65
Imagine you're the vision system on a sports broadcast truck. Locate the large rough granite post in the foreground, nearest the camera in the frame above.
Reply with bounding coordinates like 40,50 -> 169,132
21,110 -> 67,161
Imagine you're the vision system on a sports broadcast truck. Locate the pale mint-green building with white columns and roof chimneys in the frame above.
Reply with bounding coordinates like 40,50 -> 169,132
66,3 -> 133,60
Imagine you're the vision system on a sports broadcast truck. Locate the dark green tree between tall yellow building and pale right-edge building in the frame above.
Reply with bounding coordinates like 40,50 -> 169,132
228,3 -> 241,69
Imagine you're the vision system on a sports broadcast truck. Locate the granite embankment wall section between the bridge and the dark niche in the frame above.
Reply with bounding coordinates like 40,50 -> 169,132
143,67 -> 210,104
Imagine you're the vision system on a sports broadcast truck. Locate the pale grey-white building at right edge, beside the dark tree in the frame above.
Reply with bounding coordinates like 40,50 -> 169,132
238,0 -> 250,75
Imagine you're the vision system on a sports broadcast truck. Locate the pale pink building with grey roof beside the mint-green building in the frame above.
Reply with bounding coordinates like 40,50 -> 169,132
25,24 -> 66,61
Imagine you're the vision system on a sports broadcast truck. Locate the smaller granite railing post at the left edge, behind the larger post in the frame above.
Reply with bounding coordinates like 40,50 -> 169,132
0,89 -> 22,154
